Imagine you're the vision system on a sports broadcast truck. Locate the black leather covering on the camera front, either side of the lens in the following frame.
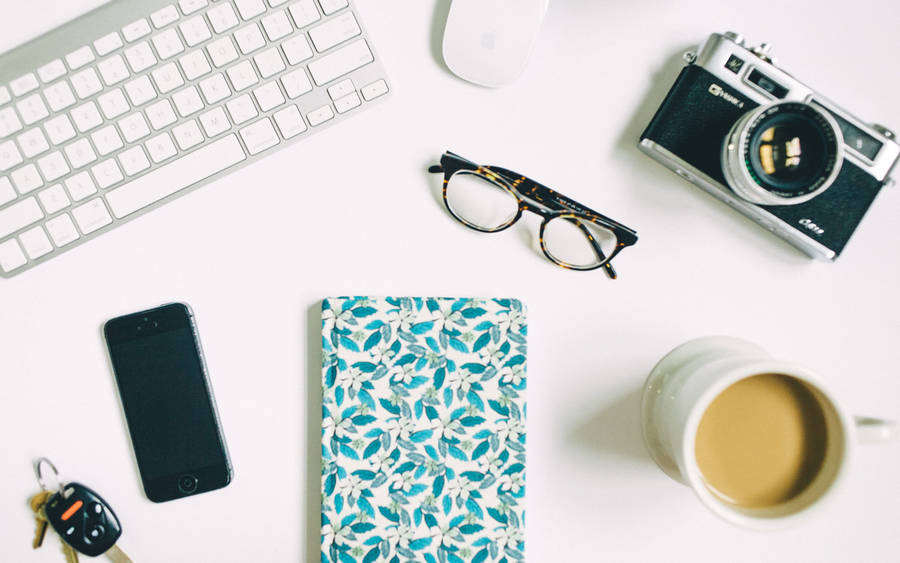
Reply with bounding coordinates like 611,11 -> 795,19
641,65 -> 882,255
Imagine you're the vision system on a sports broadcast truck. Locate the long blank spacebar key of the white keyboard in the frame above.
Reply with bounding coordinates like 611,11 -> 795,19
106,134 -> 247,219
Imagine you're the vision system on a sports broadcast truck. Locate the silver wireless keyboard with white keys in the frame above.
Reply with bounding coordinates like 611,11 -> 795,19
0,0 -> 389,277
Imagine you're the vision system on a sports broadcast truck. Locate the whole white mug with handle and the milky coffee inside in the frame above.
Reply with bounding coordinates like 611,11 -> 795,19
641,336 -> 896,529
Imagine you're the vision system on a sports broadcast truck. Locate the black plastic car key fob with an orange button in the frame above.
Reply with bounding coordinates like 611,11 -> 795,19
44,483 -> 122,557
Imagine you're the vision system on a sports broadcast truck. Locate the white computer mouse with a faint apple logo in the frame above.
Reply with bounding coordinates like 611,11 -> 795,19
444,0 -> 550,88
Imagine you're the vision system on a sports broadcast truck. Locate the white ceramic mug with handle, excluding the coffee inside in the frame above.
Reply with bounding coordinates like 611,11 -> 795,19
641,336 -> 896,529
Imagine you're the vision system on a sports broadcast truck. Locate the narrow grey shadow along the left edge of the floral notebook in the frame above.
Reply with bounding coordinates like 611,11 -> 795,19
300,301 -> 322,561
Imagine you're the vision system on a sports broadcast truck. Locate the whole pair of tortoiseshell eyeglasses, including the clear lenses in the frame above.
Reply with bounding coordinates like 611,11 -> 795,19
428,151 -> 637,279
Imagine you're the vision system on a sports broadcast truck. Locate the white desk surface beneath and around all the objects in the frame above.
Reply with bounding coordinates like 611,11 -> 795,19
0,0 -> 900,563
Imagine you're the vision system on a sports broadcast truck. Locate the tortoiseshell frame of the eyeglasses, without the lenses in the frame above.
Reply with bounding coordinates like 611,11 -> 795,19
428,151 -> 638,279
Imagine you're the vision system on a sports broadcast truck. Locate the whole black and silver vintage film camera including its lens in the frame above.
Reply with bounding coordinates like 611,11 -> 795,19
639,33 -> 900,260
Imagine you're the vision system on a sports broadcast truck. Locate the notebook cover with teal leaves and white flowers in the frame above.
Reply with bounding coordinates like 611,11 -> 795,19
322,297 -> 527,563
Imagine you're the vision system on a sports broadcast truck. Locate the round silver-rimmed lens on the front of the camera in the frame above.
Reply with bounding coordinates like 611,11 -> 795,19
722,102 -> 843,205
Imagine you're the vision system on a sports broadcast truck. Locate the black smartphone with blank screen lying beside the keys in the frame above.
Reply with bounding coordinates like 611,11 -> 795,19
104,303 -> 232,502
